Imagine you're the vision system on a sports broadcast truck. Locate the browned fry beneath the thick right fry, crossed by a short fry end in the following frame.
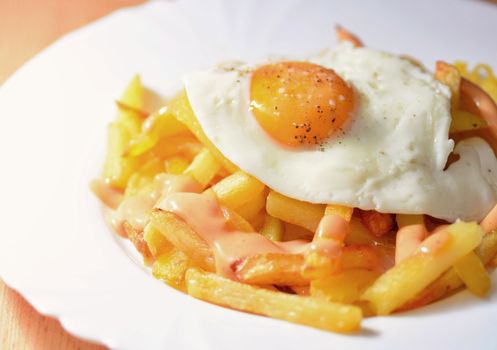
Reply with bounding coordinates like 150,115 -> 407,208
402,231 -> 497,309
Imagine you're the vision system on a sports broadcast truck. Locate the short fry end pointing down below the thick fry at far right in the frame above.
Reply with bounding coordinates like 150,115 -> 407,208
454,252 -> 491,297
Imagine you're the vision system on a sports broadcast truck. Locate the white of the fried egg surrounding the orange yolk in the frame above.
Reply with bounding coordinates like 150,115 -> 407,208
184,45 -> 497,221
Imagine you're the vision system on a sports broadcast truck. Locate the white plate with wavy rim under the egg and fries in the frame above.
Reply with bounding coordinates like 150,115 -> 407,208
0,0 -> 497,350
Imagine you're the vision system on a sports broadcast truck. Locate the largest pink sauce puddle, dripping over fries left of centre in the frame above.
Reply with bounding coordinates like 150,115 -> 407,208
157,192 -> 309,279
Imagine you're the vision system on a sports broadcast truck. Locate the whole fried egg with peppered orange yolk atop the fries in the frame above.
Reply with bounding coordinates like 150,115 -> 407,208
184,43 -> 497,221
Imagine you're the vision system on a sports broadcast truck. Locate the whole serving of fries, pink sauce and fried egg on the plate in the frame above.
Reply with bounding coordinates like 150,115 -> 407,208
92,27 -> 497,332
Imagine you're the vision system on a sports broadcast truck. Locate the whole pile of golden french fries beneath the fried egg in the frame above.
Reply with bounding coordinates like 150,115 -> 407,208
93,56 -> 497,332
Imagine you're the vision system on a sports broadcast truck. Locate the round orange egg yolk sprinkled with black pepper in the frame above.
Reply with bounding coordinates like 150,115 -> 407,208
250,62 -> 355,147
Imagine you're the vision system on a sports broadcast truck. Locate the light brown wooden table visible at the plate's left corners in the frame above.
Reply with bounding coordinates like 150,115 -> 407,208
0,0 -> 143,350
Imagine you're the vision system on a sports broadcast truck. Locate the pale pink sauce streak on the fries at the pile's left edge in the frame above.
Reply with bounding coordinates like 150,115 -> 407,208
109,174 -> 201,236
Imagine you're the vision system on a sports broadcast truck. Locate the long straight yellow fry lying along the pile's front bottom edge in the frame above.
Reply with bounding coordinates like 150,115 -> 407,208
186,269 -> 362,332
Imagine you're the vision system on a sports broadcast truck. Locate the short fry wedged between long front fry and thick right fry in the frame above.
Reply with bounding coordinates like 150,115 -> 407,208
310,269 -> 379,304
